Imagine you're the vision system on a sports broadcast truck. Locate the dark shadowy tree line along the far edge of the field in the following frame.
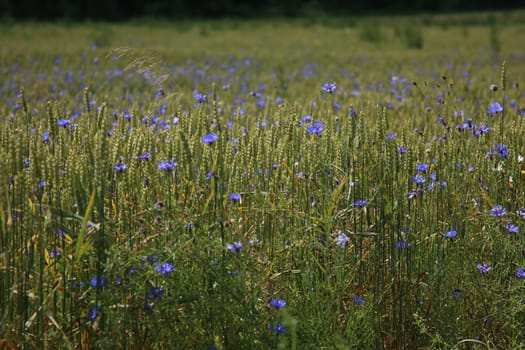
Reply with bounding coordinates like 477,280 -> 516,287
0,0 -> 525,20
